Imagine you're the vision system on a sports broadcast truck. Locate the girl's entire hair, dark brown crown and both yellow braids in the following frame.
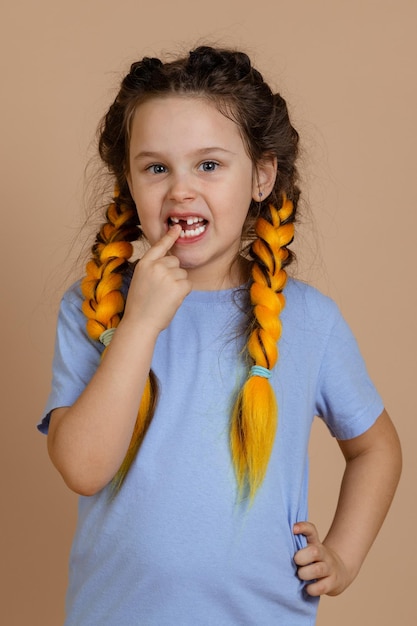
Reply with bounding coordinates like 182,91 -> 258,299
82,46 -> 299,498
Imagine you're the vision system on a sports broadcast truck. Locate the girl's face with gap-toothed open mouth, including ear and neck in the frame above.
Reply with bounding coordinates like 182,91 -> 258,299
128,96 -> 276,289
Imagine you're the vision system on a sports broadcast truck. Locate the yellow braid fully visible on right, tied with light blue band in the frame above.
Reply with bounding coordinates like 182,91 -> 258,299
230,196 -> 294,500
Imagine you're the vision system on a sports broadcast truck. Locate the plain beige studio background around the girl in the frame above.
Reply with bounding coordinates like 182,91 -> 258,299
0,0 -> 417,626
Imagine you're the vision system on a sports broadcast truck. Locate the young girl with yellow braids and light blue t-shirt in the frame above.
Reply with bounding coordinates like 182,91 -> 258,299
40,47 -> 400,626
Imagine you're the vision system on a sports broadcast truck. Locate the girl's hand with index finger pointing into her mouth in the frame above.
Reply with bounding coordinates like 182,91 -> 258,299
123,225 -> 191,334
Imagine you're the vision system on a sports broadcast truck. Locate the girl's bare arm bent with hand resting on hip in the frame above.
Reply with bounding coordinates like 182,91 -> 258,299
294,411 -> 401,596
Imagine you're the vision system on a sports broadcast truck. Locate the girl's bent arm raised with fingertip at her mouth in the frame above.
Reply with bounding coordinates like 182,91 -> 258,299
48,227 -> 191,495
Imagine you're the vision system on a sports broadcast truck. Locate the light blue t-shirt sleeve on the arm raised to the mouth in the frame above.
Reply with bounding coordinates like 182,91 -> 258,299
38,283 -> 104,434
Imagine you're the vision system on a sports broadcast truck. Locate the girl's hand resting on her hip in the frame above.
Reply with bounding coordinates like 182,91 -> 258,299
293,522 -> 351,596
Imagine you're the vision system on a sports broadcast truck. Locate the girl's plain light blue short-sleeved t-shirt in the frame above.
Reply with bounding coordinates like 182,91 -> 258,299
39,280 -> 383,626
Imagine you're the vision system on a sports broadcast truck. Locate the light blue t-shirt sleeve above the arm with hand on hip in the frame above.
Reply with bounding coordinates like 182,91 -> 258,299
316,303 -> 384,440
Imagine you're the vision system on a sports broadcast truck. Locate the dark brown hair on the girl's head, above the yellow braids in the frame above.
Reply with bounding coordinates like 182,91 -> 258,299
99,46 -> 299,244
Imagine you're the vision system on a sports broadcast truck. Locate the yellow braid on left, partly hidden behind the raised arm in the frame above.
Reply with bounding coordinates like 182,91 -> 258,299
81,189 -> 157,492
